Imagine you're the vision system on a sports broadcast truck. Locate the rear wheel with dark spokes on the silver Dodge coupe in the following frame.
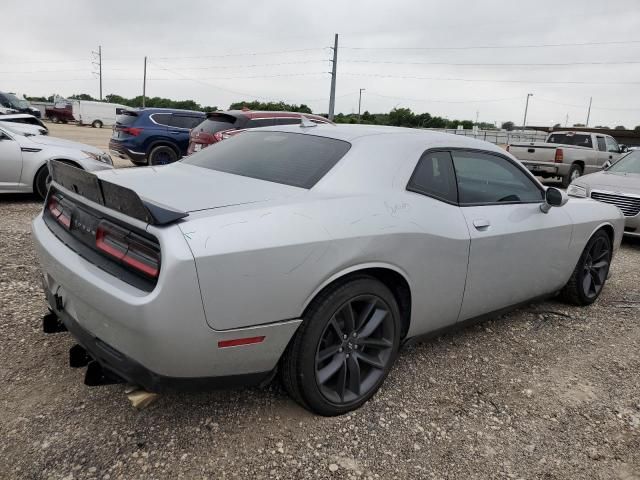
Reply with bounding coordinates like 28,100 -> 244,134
280,275 -> 401,416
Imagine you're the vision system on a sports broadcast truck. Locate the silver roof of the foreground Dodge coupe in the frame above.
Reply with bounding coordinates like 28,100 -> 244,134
252,124 -> 506,154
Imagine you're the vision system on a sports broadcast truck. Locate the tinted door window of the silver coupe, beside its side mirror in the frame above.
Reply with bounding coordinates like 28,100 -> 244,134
452,150 -> 544,205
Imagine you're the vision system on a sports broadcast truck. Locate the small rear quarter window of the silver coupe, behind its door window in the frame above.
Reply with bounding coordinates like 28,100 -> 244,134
407,152 -> 458,203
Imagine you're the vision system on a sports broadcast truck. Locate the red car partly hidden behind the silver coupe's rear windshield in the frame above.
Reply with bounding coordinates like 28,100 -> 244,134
187,110 -> 331,155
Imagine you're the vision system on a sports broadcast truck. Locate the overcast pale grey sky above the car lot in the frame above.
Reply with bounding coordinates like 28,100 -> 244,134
0,0 -> 640,128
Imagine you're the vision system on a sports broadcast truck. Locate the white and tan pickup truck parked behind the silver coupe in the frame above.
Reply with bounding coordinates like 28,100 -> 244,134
507,132 -> 627,188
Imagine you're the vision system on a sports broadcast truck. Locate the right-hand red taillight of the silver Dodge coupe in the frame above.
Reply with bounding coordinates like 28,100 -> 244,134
96,221 -> 160,278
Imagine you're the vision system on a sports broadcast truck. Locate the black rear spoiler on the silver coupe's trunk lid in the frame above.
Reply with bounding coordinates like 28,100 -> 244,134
49,160 -> 189,225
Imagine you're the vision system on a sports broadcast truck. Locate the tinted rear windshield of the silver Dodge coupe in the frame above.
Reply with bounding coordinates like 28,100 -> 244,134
182,130 -> 351,188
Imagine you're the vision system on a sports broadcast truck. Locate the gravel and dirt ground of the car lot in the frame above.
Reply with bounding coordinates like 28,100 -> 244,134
0,126 -> 640,480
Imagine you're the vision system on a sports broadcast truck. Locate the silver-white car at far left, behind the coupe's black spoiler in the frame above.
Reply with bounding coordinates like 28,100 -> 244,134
0,124 -> 113,198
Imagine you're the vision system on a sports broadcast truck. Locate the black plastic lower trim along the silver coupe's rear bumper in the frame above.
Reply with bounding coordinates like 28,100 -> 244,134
55,310 -> 274,393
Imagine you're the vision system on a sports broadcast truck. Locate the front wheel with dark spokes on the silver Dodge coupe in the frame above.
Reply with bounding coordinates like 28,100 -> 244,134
561,230 -> 613,306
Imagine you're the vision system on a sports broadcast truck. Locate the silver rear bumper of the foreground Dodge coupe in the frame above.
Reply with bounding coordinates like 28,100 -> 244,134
33,215 -> 301,391
